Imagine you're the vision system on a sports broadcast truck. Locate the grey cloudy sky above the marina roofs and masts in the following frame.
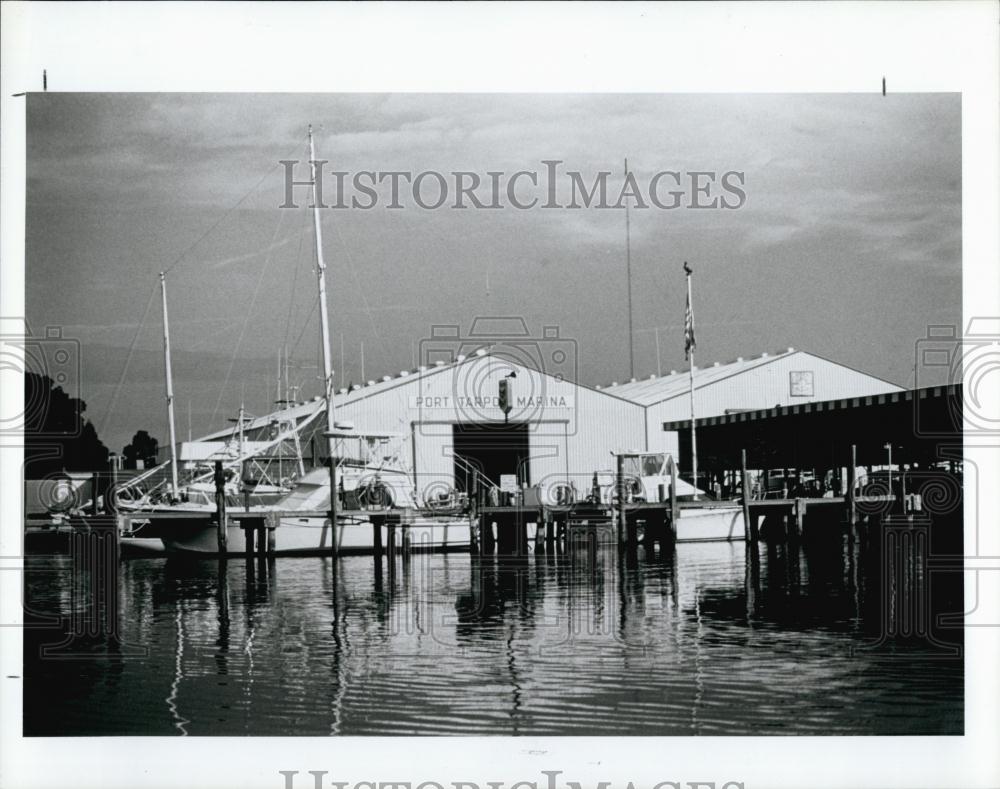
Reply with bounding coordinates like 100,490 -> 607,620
25,93 -> 961,451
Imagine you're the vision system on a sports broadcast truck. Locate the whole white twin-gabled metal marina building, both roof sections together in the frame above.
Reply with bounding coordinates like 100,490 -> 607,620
201,348 -> 901,493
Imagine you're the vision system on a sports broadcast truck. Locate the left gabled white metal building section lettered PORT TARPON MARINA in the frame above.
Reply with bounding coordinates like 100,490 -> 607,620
201,351 -> 647,492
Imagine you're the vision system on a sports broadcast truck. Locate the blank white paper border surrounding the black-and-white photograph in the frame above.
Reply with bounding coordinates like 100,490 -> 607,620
0,0 -> 1000,789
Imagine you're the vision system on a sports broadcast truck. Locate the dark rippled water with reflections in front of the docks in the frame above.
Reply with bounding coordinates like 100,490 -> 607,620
24,538 -> 963,735
